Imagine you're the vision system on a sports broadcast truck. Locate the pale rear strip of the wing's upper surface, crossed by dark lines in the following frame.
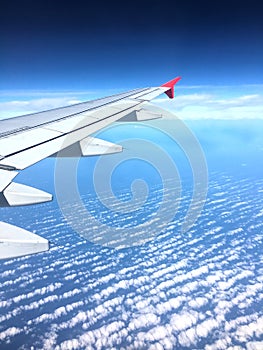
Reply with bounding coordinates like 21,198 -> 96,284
0,98 -> 142,170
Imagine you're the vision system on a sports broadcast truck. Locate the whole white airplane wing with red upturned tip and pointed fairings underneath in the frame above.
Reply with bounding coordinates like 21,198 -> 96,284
0,77 -> 181,259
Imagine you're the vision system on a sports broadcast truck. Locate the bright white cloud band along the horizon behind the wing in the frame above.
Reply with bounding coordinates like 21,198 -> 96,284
0,85 -> 263,119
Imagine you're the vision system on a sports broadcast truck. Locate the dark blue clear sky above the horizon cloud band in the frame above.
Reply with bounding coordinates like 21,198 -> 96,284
0,0 -> 263,90
